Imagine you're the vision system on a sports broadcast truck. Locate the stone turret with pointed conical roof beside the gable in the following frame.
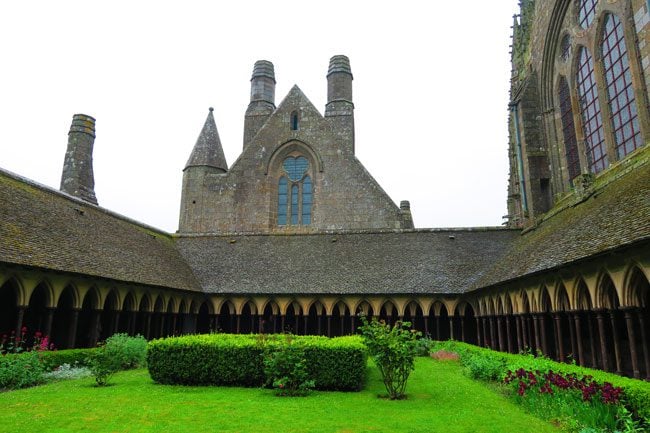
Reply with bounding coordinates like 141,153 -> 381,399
179,107 -> 228,231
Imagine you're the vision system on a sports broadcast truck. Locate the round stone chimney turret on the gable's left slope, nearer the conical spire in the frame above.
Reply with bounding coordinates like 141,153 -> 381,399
244,60 -> 275,147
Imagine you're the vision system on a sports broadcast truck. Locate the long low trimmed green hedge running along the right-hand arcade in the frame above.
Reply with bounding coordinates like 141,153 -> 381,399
434,340 -> 650,426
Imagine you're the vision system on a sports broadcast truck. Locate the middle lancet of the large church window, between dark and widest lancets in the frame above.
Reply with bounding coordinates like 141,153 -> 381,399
576,47 -> 607,173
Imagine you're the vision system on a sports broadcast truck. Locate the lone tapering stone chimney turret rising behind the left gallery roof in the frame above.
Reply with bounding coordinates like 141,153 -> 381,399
60,114 -> 97,204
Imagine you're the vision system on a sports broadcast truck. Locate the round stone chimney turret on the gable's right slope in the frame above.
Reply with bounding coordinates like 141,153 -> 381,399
325,55 -> 354,154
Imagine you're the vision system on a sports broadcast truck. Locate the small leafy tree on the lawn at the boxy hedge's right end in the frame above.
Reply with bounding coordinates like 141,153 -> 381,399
360,316 -> 420,400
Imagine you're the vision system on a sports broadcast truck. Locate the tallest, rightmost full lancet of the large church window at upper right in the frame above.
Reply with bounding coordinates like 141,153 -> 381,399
602,14 -> 642,158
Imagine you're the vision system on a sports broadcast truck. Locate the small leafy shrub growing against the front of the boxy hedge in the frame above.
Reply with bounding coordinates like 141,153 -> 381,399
264,336 -> 315,396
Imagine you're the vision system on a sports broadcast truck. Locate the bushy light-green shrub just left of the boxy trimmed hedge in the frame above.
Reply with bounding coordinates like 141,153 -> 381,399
88,334 -> 147,386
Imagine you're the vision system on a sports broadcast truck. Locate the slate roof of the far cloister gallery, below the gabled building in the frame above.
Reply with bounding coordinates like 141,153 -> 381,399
176,228 -> 519,294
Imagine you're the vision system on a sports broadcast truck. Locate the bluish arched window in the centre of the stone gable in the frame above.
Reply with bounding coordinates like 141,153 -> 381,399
278,156 -> 313,226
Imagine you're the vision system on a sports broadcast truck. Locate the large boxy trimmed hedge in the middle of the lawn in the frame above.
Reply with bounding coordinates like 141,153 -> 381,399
147,334 -> 367,391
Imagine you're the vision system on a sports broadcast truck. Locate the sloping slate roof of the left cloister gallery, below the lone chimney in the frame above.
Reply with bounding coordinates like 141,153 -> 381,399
0,170 -> 200,290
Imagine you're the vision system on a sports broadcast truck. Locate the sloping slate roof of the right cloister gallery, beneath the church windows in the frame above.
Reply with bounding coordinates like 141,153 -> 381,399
470,162 -> 650,287
